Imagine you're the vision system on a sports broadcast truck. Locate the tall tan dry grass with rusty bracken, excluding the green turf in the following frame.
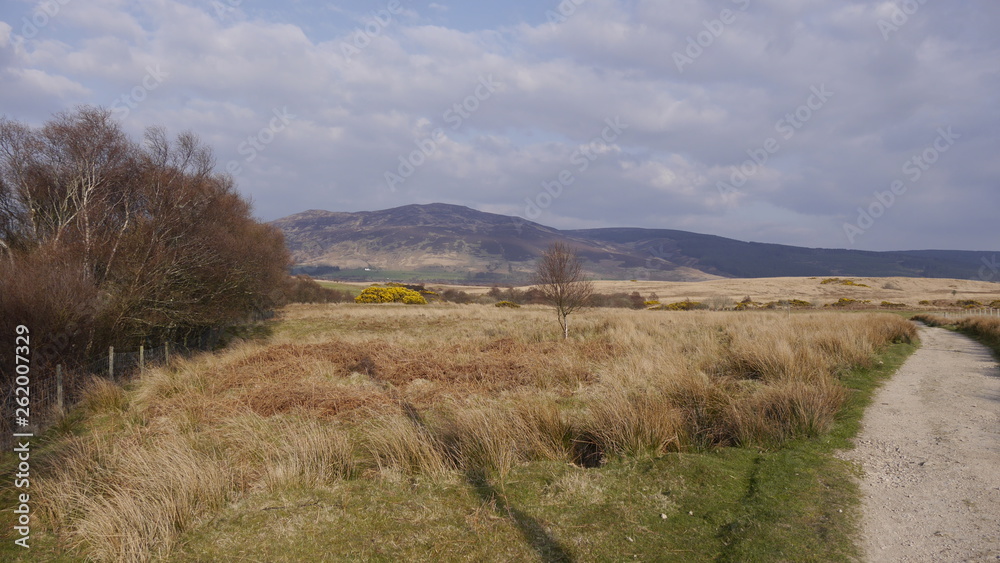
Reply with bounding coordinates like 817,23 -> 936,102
27,305 -> 915,560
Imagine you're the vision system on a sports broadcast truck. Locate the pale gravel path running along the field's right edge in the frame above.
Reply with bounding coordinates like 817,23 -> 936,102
845,327 -> 1000,562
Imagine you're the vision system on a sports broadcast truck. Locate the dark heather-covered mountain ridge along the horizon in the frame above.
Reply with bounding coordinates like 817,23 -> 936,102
272,203 -> 989,282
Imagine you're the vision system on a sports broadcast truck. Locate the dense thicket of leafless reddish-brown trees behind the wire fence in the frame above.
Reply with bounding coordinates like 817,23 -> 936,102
0,107 -> 288,414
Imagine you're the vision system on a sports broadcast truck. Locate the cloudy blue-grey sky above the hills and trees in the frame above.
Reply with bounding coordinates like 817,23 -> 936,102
0,0 -> 1000,251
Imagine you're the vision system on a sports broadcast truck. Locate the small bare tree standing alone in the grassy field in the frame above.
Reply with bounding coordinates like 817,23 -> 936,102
534,242 -> 594,338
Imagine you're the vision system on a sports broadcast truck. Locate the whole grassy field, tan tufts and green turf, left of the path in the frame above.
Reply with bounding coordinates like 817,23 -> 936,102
0,304 -> 914,561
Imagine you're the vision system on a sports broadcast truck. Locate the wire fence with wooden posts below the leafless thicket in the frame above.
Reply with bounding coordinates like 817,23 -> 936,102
0,328 -> 226,450
